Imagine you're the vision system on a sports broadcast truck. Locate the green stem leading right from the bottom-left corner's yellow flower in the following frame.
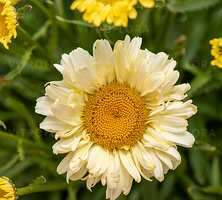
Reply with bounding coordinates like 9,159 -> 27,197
17,182 -> 68,196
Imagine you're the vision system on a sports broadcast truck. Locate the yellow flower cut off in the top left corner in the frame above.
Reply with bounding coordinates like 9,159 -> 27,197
0,0 -> 17,49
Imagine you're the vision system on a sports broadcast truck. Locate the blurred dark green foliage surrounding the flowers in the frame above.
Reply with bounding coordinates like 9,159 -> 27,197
0,0 -> 222,200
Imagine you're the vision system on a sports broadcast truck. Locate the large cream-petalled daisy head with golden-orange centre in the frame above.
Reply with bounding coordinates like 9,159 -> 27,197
36,36 -> 197,200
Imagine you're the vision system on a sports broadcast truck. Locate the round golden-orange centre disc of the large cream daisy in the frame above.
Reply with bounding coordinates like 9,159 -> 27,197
83,83 -> 148,150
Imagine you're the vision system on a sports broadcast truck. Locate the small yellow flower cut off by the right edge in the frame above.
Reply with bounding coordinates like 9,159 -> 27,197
210,38 -> 222,68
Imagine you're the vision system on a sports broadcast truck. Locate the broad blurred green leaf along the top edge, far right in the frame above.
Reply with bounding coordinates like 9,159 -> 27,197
167,0 -> 220,12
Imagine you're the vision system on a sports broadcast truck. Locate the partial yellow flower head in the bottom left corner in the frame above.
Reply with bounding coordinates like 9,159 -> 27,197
0,177 -> 16,200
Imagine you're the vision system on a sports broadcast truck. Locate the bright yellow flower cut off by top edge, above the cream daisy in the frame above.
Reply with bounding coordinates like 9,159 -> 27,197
71,0 -> 155,27
